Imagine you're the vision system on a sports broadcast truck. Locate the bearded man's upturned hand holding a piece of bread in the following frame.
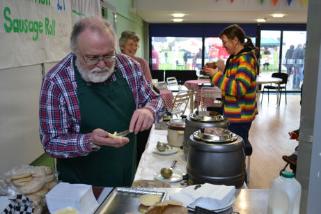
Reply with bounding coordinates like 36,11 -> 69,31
91,129 -> 129,148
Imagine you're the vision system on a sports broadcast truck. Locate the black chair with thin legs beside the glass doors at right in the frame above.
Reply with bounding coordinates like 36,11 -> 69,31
261,73 -> 289,104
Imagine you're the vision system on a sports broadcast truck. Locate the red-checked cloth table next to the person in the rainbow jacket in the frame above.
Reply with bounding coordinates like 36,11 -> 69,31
184,79 -> 221,109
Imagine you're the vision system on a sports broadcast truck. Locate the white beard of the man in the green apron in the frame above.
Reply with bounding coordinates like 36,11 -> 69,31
76,60 -> 115,83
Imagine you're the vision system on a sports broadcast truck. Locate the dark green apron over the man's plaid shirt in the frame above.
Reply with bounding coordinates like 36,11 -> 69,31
57,66 -> 136,187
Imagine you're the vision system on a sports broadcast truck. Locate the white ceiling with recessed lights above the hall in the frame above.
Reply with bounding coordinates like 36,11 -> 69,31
132,0 -> 307,23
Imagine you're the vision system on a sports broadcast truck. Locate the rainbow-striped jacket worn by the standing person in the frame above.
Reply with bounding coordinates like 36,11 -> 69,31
212,48 -> 258,123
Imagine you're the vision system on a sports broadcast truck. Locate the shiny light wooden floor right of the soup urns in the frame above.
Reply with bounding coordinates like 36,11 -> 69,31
248,94 -> 301,188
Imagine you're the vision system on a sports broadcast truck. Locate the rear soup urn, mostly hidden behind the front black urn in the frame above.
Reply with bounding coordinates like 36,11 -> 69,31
183,111 -> 229,160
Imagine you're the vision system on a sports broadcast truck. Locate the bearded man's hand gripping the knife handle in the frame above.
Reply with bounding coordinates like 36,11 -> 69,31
129,108 -> 154,134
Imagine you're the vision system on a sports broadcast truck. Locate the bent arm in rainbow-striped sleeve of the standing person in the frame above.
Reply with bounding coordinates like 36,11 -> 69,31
212,55 -> 256,97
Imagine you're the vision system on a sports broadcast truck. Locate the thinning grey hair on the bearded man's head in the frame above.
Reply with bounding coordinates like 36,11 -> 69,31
70,17 -> 117,53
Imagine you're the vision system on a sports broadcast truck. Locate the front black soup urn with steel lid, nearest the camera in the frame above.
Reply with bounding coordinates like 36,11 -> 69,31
187,128 -> 245,188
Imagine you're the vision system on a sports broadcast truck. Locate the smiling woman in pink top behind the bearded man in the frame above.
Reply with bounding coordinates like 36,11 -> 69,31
119,31 -> 152,83
